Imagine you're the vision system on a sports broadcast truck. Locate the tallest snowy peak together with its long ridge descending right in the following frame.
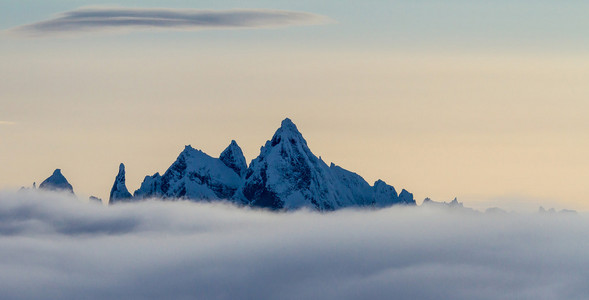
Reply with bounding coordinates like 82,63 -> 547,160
236,118 -> 415,211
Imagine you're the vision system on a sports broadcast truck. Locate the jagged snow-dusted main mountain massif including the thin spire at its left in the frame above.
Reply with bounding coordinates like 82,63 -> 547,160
111,118 -> 415,211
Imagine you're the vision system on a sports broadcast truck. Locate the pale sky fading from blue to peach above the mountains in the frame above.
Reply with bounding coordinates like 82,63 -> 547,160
0,0 -> 589,210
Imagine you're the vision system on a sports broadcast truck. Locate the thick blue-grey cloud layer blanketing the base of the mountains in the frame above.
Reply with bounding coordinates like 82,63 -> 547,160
0,192 -> 589,299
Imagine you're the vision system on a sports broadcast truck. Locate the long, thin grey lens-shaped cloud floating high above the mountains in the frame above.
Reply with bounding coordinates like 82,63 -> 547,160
9,7 -> 329,36
